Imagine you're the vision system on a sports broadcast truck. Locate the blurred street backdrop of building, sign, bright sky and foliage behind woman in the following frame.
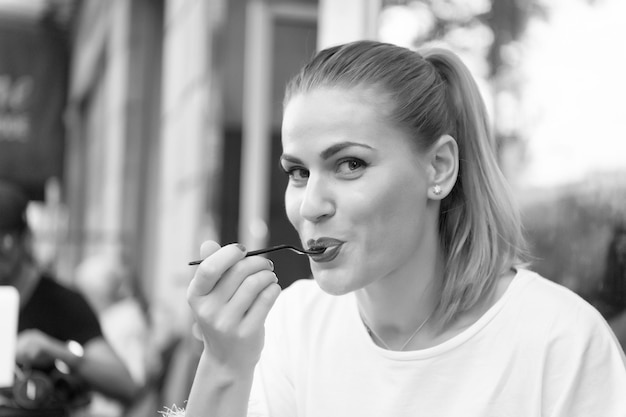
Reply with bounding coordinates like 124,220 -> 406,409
0,0 -> 626,416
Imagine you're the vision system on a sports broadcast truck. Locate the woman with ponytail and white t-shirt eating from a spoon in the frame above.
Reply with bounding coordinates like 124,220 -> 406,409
182,41 -> 626,417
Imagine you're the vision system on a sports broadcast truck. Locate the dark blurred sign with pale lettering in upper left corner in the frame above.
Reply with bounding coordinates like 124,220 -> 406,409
0,19 -> 68,199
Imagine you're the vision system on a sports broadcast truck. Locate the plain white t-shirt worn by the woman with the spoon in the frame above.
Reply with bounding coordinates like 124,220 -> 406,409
248,270 -> 626,417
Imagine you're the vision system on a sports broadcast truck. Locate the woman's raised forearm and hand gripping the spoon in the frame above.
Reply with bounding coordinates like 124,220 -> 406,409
186,242 -> 280,417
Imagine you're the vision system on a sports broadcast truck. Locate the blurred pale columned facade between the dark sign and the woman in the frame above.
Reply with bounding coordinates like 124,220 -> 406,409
57,0 -> 379,403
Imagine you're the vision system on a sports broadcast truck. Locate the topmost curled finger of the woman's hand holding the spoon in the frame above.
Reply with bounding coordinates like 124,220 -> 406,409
187,242 -> 245,300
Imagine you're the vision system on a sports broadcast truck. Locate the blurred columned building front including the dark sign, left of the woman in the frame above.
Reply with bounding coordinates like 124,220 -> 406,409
0,0 -> 381,331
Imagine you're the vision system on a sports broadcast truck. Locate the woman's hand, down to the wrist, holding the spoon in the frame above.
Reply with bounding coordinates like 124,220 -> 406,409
187,241 -> 280,373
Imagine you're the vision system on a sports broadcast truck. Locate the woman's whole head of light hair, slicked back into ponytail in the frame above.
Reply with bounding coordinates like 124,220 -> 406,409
284,41 -> 526,325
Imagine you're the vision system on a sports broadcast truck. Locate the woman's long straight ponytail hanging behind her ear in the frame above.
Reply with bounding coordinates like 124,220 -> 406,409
423,49 -> 526,323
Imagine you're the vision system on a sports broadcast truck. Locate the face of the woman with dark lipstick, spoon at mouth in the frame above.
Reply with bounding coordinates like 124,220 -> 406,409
281,89 -> 437,295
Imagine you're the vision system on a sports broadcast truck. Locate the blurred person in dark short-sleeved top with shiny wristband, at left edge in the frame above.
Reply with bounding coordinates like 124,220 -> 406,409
0,182 -> 137,416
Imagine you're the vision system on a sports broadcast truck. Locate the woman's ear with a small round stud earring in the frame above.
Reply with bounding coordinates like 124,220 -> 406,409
428,135 -> 459,200
